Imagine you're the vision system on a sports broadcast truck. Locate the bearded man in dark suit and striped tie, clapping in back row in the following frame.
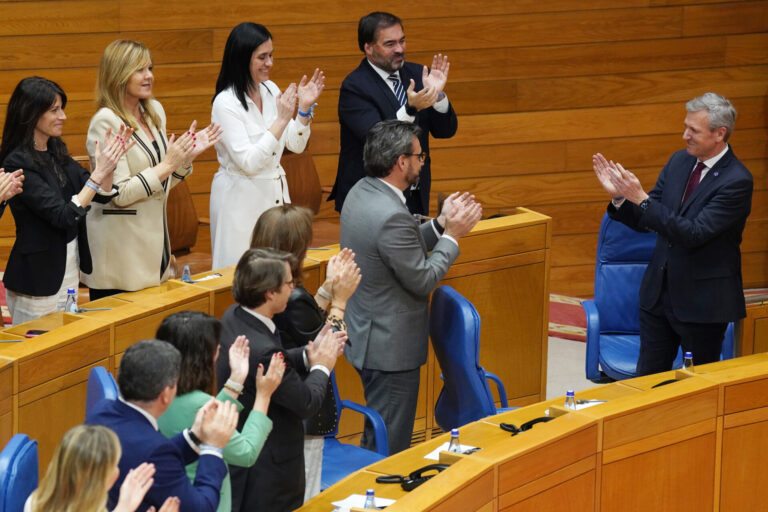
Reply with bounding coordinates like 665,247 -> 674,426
328,12 -> 458,215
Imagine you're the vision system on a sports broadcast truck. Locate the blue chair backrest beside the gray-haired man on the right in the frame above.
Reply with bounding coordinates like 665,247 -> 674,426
595,214 -> 656,333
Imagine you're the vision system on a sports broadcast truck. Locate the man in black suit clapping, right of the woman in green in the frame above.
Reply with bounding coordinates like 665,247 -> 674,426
216,249 -> 346,512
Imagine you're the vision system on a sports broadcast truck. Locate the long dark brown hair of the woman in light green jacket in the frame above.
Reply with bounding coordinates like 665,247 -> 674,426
155,311 -> 221,395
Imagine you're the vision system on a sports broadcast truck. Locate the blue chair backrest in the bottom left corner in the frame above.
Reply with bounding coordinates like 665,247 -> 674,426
0,434 -> 38,512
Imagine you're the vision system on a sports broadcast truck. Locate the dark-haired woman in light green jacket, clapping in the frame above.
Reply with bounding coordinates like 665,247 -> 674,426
156,311 -> 285,512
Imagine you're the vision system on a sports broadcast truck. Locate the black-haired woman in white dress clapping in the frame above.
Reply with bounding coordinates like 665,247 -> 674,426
210,22 -> 325,268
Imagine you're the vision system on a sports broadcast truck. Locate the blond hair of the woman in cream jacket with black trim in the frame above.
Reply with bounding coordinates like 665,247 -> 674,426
96,39 -> 160,130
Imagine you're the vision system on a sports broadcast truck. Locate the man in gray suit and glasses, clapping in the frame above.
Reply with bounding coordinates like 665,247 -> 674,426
340,120 -> 482,453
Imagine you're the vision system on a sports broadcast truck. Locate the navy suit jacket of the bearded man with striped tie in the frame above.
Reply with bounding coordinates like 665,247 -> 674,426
328,58 -> 458,215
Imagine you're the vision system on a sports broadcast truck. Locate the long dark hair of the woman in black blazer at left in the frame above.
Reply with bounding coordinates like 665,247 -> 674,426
0,76 -> 68,165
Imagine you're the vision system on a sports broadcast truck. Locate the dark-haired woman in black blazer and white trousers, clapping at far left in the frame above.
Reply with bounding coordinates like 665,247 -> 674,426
0,77 -> 132,324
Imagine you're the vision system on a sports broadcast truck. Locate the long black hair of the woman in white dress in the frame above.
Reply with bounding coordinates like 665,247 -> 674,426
213,21 -> 272,110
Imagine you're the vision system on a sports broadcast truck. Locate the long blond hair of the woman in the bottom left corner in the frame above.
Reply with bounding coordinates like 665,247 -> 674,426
31,425 -> 121,512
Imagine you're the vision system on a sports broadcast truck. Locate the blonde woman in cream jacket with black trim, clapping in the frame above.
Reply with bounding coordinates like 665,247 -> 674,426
83,40 -> 221,300
